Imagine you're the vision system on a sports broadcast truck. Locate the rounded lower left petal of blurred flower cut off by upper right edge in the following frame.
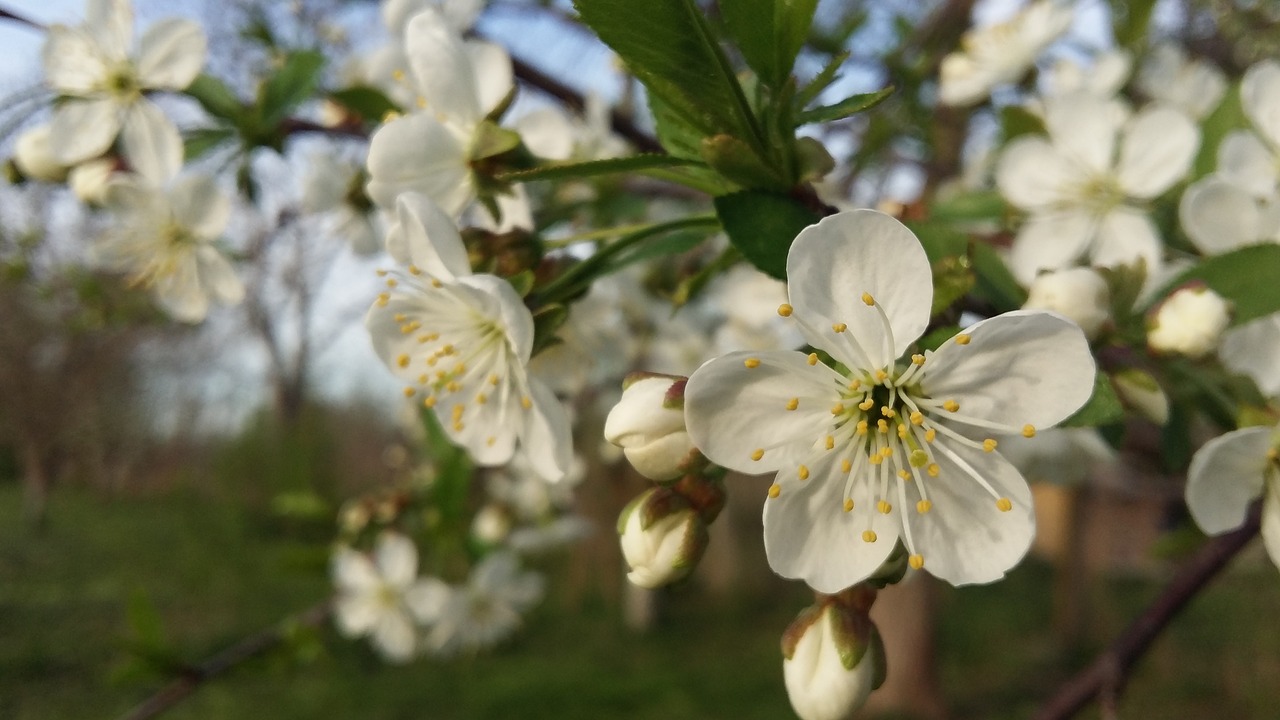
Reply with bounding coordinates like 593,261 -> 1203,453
1178,176 -> 1262,255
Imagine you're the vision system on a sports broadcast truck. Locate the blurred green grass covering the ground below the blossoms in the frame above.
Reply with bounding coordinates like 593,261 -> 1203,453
0,486 -> 1280,720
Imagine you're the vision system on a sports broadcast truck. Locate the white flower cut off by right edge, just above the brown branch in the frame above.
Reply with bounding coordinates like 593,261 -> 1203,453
1187,427 -> 1280,566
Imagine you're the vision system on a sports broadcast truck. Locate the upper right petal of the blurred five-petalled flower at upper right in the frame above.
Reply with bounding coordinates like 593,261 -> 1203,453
1116,108 -> 1199,200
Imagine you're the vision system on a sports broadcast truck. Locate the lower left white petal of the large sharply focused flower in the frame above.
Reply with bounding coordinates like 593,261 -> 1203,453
764,451 -> 900,593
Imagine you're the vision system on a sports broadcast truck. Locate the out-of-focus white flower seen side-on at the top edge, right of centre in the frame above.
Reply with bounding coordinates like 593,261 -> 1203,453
938,0 -> 1073,105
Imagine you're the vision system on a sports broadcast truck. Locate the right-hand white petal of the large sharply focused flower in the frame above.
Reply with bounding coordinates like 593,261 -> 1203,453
920,310 -> 1096,428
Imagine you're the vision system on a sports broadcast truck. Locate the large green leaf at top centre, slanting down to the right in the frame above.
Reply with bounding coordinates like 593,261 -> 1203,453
573,0 -> 765,151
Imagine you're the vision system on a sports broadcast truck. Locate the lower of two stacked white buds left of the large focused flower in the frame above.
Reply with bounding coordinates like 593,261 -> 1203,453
618,488 -> 707,588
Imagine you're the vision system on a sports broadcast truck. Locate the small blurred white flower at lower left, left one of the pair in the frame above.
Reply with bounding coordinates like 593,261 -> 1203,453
332,532 -> 448,662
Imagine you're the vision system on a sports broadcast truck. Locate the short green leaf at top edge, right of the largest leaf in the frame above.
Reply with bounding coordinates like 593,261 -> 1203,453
719,0 -> 818,87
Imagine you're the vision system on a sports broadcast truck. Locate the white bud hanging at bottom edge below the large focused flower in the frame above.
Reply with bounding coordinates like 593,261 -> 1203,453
782,598 -> 884,720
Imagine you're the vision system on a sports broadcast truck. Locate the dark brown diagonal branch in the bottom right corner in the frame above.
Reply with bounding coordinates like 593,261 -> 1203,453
1036,505 -> 1262,720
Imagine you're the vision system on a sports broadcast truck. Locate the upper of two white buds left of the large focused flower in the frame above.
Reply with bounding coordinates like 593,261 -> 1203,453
604,374 -> 694,482
